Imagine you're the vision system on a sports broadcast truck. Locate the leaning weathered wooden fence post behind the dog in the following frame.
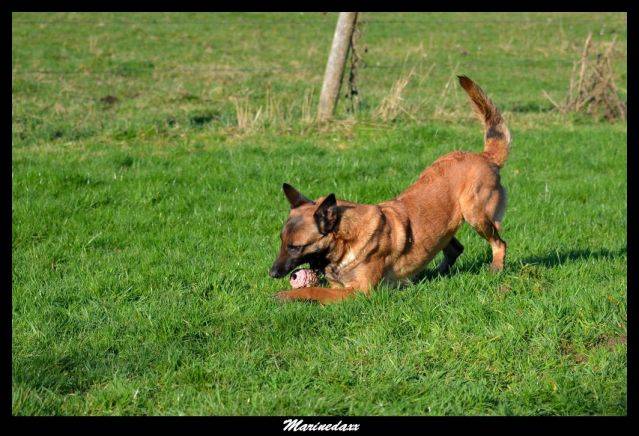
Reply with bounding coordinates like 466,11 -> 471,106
317,12 -> 357,121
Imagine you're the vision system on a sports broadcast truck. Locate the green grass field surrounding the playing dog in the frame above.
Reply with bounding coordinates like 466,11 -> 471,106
12,13 -> 627,415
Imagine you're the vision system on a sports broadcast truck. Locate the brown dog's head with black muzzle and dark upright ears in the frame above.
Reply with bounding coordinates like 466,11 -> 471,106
269,183 -> 339,278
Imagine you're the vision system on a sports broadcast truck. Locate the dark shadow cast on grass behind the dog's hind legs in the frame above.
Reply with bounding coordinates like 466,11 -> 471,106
418,247 -> 628,281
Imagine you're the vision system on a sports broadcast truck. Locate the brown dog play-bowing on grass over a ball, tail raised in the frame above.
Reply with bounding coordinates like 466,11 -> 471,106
269,76 -> 510,303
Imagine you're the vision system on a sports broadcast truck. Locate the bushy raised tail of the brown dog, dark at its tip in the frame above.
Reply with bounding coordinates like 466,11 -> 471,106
457,76 -> 510,168
